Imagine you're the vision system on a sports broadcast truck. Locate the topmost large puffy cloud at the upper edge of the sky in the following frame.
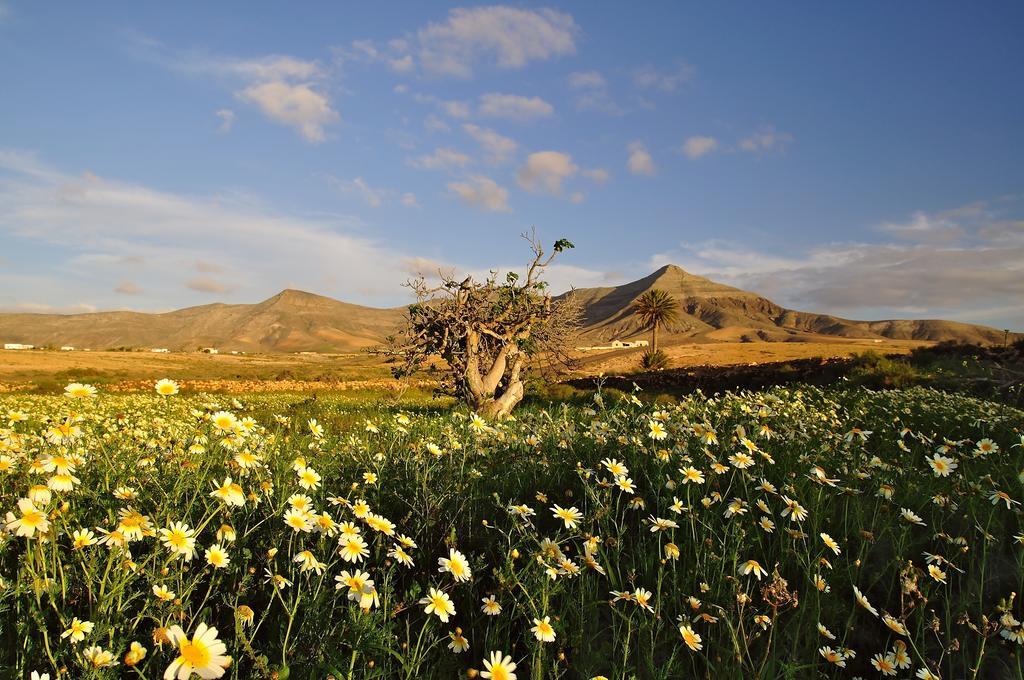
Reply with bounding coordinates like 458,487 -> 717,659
416,5 -> 579,78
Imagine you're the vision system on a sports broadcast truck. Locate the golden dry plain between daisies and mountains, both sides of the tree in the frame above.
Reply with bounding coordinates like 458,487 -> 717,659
0,339 -> 929,391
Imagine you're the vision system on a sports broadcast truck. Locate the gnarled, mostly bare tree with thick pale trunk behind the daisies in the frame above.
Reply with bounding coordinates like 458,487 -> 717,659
390,232 -> 582,418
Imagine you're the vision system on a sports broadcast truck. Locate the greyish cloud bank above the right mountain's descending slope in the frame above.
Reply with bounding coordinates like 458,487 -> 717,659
651,202 -> 1024,329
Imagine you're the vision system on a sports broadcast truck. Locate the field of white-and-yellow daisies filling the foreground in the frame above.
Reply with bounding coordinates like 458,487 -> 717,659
0,381 -> 1024,680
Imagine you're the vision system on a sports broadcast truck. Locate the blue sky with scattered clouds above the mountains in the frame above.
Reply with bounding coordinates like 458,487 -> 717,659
0,0 -> 1024,330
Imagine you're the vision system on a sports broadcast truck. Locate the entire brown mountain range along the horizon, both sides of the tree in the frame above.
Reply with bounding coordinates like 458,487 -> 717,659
0,264 -> 1004,352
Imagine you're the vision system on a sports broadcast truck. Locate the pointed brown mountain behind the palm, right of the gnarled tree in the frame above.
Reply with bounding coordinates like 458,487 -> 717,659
572,264 -> 1004,344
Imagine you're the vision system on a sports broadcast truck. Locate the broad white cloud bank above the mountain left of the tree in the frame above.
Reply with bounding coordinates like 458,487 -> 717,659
0,152 -> 425,308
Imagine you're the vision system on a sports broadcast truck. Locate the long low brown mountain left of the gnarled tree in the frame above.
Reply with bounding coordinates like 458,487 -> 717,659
0,290 -> 404,352
